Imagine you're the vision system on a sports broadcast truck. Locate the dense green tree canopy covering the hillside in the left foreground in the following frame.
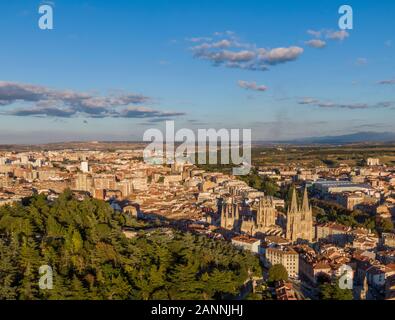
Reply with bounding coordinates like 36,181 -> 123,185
0,191 -> 261,300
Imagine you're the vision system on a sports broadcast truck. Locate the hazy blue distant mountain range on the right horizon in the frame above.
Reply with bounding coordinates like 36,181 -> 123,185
274,132 -> 395,144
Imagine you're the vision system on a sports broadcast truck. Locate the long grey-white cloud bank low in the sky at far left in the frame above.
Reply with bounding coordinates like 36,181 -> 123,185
0,81 -> 183,118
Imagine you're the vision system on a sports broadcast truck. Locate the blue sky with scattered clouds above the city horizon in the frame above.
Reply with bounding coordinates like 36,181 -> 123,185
0,0 -> 395,143
